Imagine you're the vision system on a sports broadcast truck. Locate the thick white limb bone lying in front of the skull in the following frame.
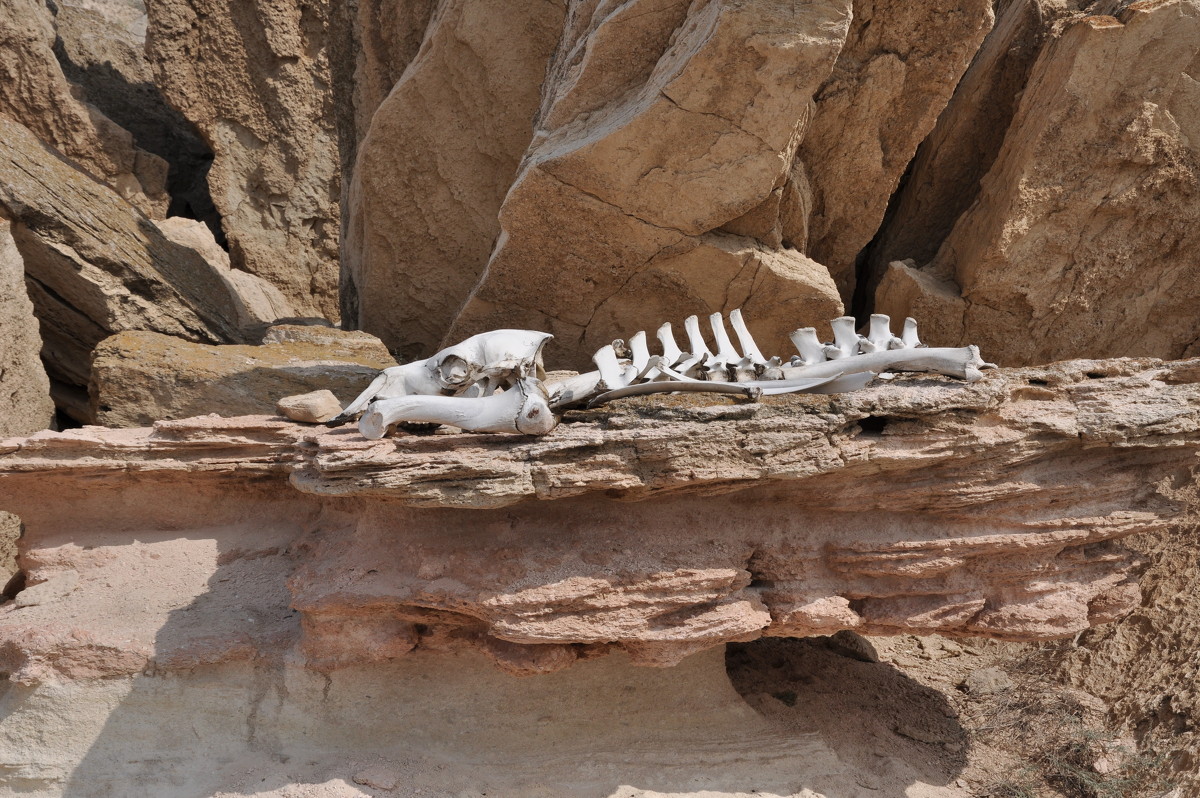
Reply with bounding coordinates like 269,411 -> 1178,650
359,377 -> 558,439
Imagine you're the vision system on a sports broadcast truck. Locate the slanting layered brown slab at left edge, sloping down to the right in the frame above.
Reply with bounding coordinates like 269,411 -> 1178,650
0,116 -> 278,421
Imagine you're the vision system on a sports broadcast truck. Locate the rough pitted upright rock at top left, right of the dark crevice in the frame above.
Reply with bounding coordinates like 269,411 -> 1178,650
146,0 -> 341,320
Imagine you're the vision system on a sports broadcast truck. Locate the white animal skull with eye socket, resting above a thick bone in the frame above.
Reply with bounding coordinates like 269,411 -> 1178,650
326,330 -> 554,427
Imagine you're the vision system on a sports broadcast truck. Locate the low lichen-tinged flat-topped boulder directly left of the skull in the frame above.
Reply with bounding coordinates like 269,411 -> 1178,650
89,325 -> 396,427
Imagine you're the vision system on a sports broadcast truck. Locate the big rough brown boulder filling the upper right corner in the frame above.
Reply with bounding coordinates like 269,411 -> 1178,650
876,0 -> 1200,364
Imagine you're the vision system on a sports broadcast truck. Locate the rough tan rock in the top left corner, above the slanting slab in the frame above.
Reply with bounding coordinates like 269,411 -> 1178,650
0,0 -> 167,216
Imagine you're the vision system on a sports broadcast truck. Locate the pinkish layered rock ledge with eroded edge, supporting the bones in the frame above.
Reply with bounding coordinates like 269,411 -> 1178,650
0,359 -> 1200,680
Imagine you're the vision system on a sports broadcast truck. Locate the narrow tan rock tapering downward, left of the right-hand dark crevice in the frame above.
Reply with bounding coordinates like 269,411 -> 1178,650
797,0 -> 992,298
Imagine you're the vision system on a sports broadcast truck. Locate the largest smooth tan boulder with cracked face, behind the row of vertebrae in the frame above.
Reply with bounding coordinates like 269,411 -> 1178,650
444,0 -> 850,365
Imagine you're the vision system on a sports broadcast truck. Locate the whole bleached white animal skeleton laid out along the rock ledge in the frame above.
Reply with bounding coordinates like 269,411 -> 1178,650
328,310 -> 995,438
